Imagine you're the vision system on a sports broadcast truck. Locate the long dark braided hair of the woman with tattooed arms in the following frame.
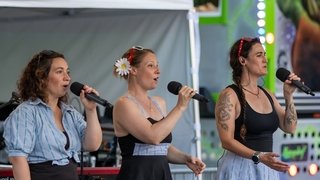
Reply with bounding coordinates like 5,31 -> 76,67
229,38 -> 261,140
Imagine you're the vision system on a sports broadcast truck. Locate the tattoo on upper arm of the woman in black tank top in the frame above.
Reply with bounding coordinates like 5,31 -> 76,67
216,94 -> 233,131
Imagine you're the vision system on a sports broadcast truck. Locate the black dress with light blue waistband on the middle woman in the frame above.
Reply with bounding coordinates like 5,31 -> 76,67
117,118 -> 172,180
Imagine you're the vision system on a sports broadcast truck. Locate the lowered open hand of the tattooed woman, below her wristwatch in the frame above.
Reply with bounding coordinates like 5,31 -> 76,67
259,152 -> 289,172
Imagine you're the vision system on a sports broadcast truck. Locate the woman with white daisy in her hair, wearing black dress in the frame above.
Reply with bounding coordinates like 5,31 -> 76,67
113,46 -> 205,180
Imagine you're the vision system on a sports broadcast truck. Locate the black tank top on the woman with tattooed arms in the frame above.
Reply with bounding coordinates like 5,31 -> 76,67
228,84 -> 279,152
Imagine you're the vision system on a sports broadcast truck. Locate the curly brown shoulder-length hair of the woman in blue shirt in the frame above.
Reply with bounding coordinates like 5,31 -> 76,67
17,50 -> 68,102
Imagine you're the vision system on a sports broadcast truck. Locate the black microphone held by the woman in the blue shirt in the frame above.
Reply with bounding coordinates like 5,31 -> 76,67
70,82 -> 112,108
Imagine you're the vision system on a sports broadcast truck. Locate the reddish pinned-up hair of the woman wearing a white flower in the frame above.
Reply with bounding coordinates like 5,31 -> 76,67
113,46 -> 155,79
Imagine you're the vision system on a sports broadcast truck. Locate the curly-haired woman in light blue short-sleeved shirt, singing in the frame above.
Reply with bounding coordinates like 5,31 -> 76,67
4,50 -> 102,180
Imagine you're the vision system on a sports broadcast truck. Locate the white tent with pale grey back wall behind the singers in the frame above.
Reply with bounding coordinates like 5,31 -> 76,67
0,0 -> 201,174
